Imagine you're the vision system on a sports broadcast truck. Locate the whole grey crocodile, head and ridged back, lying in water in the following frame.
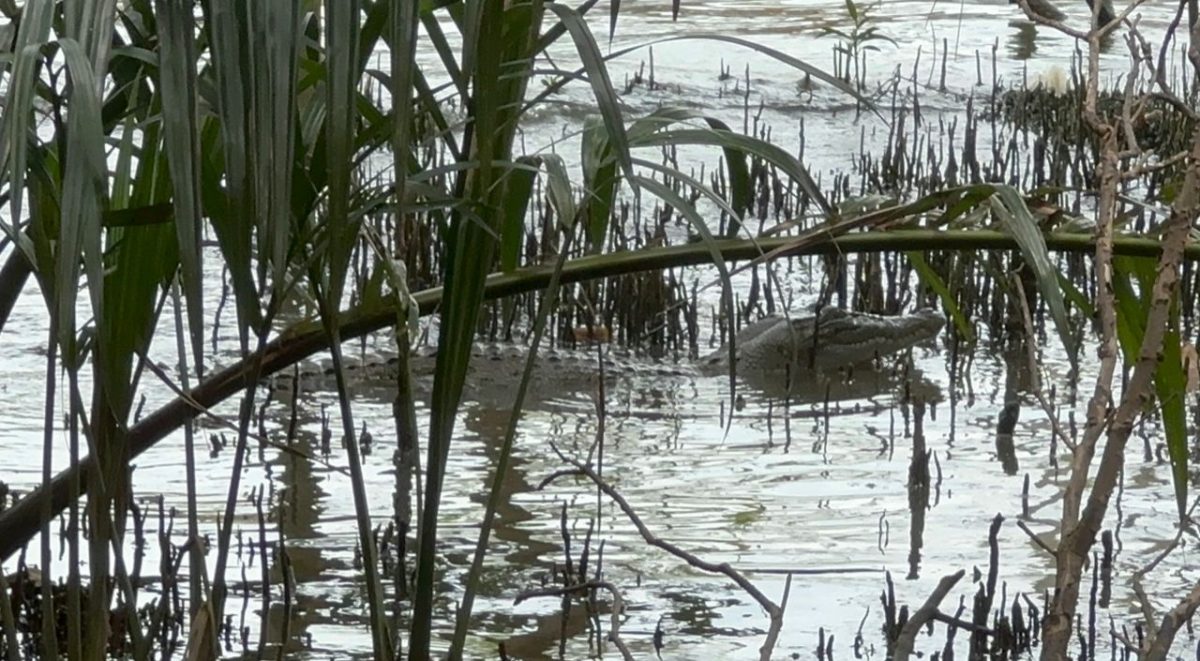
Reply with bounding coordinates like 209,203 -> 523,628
272,307 -> 944,399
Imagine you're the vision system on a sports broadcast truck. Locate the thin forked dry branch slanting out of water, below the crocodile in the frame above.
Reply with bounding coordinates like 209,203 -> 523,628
538,453 -> 792,661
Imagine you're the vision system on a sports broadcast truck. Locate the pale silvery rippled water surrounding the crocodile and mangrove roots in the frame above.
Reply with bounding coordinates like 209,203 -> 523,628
0,0 -> 1195,659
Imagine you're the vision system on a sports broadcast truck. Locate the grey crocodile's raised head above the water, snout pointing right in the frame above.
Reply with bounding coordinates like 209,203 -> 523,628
702,307 -> 944,372
